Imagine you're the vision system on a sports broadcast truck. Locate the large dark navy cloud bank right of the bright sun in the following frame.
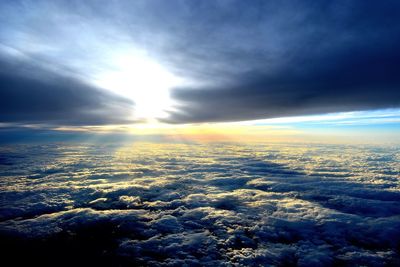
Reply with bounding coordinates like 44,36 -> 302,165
161,1 -> 400,122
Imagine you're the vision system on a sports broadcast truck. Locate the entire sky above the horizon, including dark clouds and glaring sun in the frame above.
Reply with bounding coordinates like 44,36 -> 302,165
0,1 -> 400,142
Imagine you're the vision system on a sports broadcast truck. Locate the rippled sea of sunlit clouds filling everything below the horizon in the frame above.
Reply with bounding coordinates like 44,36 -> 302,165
0,143 -> 400,266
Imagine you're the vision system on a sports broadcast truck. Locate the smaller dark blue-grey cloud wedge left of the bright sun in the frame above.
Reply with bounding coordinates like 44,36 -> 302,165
0,55 -> 133,125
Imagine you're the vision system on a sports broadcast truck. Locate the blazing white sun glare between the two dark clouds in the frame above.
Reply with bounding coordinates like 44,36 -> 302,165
95,48 -> 182,122
